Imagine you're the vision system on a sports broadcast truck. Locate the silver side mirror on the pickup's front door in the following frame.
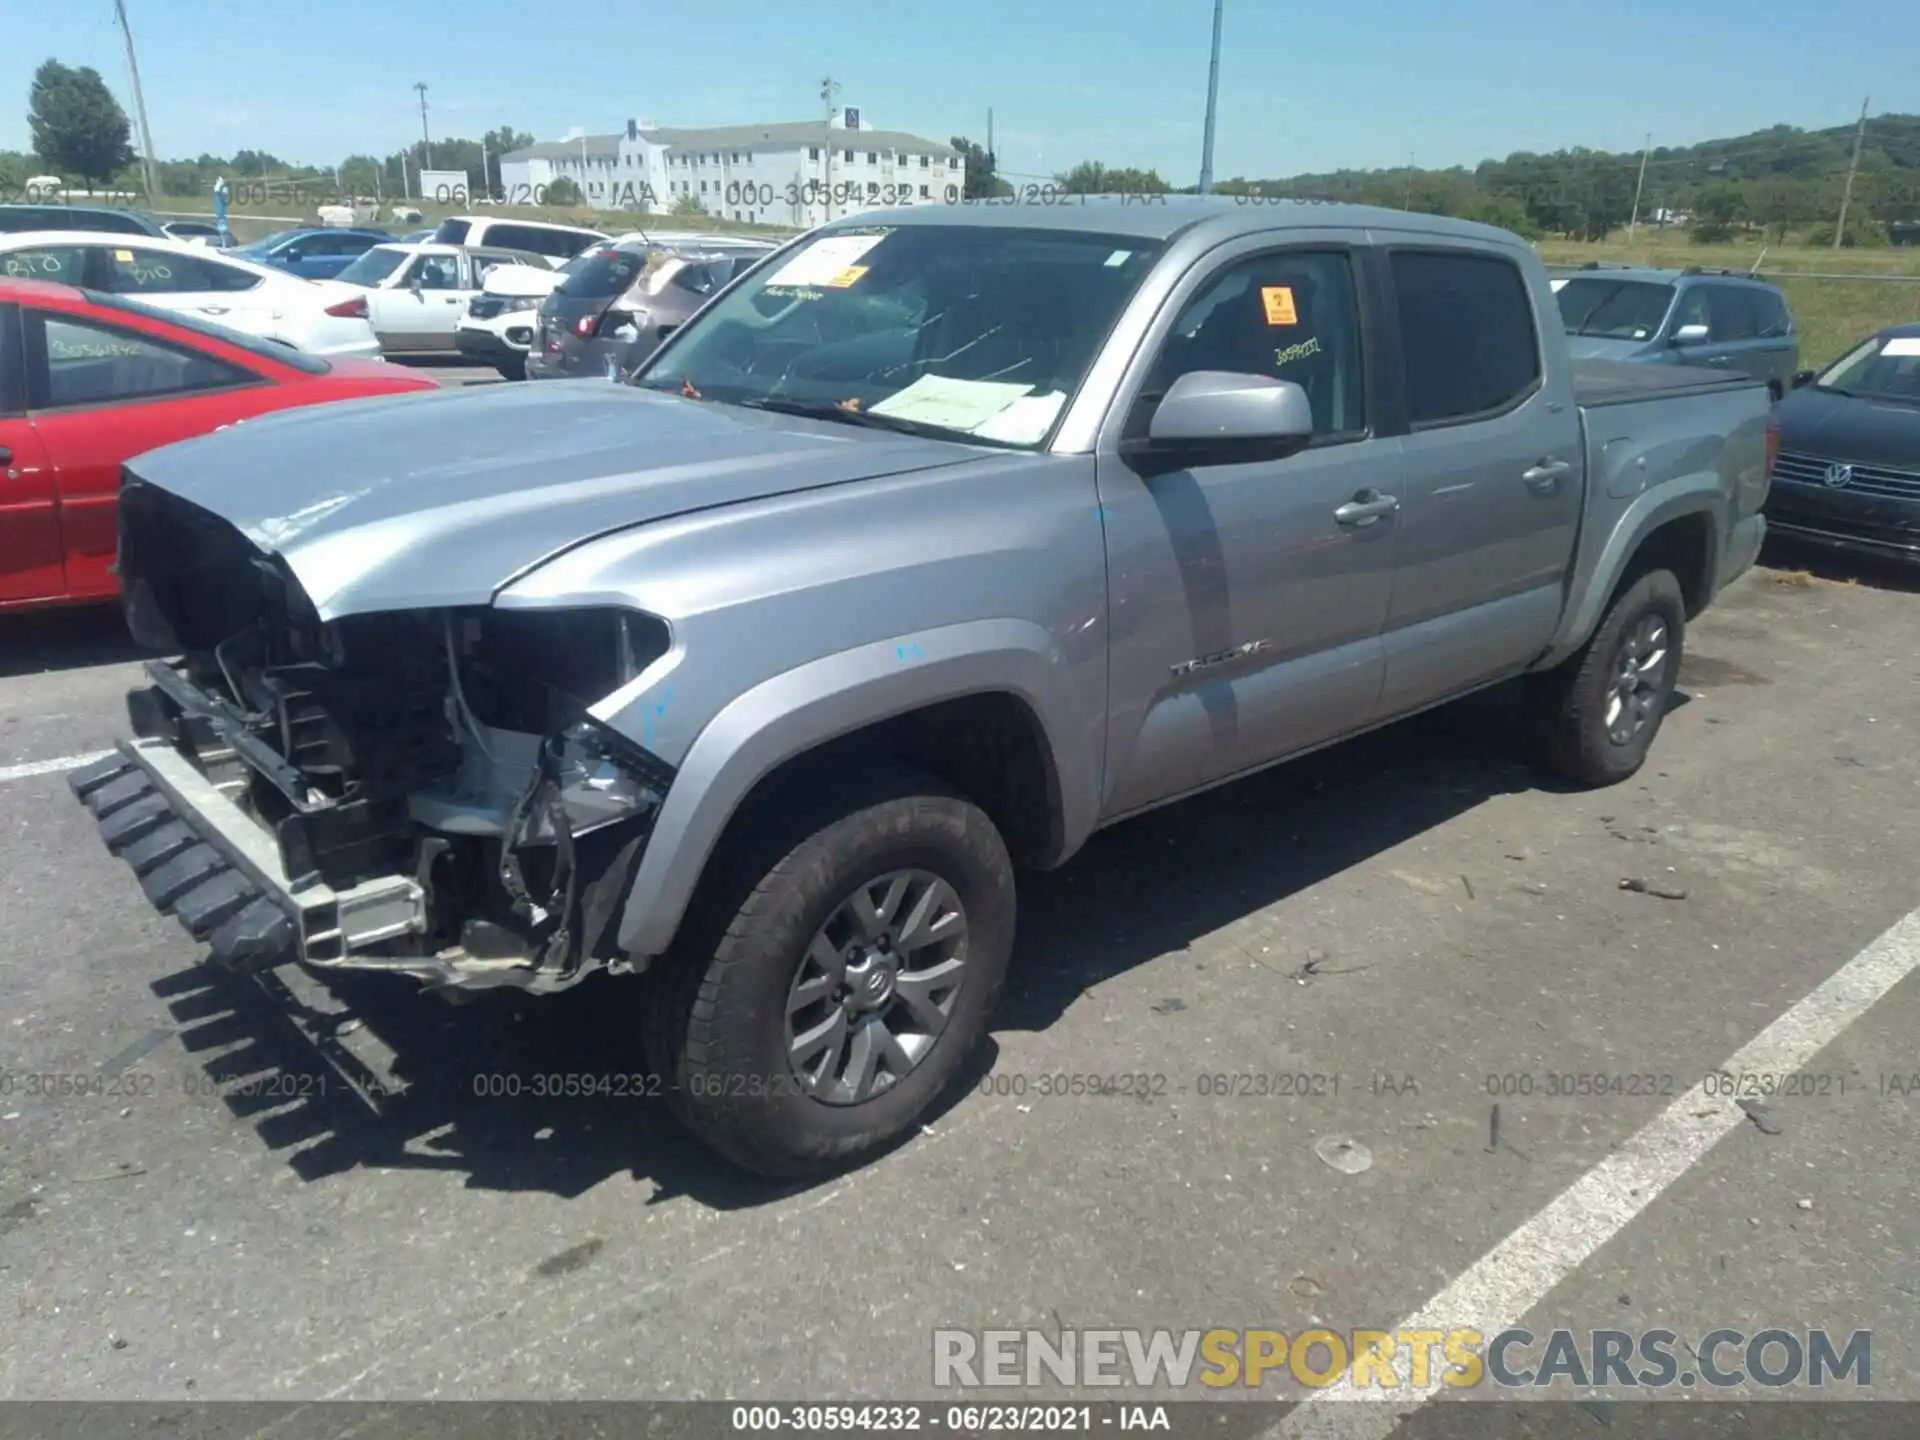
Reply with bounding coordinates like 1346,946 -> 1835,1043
1121,371 -> 1313,472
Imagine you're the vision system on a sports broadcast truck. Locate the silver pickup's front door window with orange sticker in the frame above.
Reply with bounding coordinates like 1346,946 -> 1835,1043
1142,250 -> 1367,436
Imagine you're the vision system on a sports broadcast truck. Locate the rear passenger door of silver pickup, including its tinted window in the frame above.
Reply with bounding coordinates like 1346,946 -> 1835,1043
1380,253 -> 1584,718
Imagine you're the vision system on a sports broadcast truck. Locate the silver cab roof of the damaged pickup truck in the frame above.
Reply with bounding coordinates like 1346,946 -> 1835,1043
820,186 -> 1515,246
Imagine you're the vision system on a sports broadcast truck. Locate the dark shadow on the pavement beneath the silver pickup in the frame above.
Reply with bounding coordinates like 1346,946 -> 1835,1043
154,687 -> 1605,1210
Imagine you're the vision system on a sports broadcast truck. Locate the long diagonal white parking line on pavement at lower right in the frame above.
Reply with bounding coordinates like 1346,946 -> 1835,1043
1267,910 -> 1920,1440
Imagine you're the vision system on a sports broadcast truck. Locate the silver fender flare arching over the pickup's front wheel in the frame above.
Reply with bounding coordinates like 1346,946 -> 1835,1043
618,620 -> 1100,962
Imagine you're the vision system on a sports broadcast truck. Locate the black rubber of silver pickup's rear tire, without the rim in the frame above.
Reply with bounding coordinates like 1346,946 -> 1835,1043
1528,570 -> 1686,785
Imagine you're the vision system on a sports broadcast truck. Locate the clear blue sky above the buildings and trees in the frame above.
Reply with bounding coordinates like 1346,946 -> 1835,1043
0,0 -> 1920,182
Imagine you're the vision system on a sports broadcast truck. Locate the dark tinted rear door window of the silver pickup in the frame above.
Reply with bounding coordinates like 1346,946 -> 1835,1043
1392,250 -> 1540,426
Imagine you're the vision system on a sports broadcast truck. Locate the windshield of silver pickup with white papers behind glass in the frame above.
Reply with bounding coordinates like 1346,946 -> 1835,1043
632,225 -> 1160,447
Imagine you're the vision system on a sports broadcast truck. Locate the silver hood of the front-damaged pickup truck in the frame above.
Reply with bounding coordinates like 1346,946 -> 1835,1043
127,380 -> 981,620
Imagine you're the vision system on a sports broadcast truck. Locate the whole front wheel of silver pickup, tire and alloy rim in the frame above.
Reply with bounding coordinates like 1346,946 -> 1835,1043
647,776 -> 1014,1175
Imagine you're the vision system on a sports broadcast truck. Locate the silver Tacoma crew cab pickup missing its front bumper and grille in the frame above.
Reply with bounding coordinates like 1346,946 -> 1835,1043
73,198 -> 1774,1173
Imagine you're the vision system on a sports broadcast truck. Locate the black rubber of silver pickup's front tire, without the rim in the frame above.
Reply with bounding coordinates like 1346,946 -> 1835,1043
647,772 -> 1016,1177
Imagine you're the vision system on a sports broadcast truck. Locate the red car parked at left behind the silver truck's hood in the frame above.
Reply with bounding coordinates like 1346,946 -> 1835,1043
0,278 -> 436,611
